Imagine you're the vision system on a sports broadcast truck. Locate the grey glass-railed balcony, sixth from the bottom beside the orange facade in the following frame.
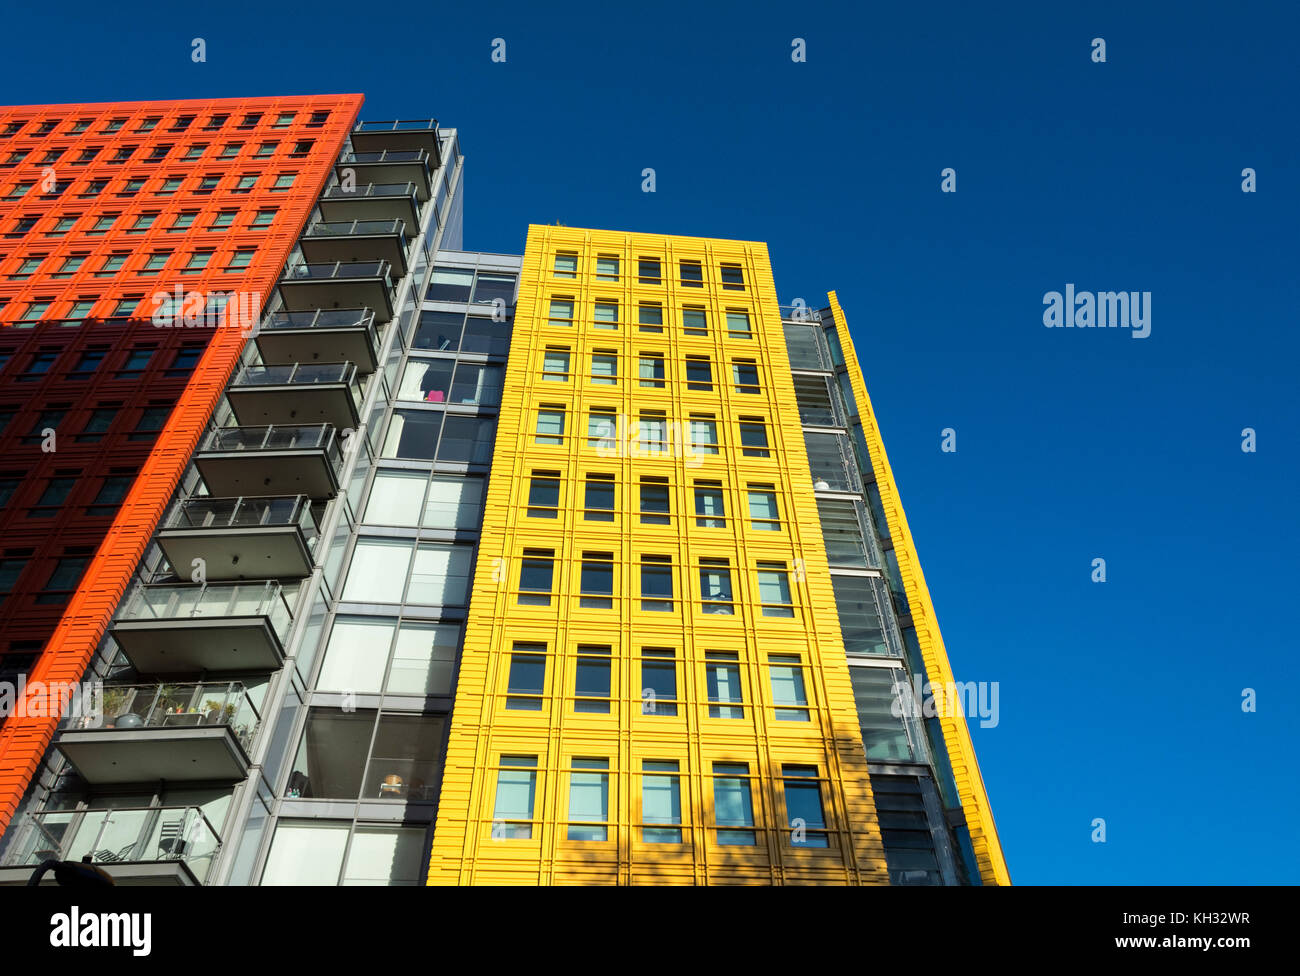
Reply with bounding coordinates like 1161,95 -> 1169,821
226,363 -> 361,428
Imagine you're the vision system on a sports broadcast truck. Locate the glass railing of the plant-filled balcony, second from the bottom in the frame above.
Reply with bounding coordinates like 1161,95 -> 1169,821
59,681 -> 261,752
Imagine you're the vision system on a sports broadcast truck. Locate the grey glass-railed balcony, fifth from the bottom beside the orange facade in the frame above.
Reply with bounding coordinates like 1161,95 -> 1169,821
194,424 -> 343,499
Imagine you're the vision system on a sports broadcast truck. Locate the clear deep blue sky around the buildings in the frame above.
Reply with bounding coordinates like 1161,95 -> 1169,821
0,0 -> 1300,884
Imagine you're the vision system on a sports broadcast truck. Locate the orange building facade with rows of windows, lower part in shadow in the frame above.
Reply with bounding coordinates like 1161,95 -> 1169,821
0,95 -> 361,830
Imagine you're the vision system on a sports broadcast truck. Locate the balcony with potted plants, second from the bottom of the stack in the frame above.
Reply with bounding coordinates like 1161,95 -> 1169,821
55,681 -> 261,785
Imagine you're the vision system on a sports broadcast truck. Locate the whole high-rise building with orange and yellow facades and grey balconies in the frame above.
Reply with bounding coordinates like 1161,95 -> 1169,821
0,96 -> 1009,885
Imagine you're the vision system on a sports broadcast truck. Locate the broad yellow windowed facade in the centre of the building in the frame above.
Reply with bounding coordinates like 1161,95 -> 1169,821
429,226 -> 888,885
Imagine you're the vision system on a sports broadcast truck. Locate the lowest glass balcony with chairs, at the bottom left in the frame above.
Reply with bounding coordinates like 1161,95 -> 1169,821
0,807 -> 221,885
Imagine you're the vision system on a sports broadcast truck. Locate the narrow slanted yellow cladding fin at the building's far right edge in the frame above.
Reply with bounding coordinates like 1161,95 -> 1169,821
827,291 -> 1011,885
